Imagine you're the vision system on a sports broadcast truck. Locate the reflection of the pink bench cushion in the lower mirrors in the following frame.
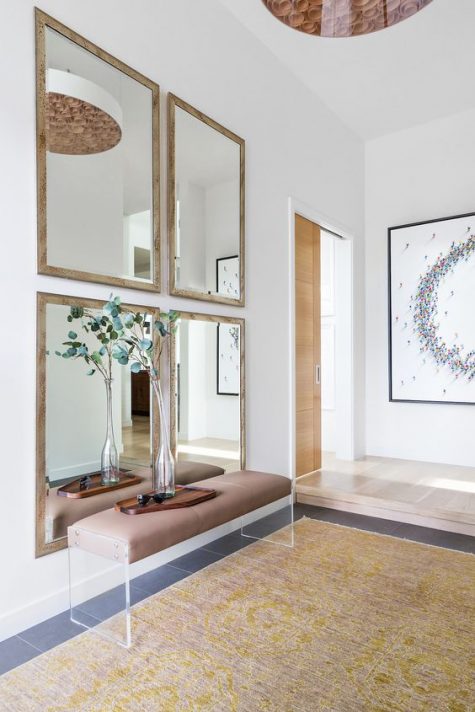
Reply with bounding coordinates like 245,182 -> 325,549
46,460 -> 224,539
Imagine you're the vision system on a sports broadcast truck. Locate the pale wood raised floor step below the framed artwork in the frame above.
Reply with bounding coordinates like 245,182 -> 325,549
297,452 -> 475,535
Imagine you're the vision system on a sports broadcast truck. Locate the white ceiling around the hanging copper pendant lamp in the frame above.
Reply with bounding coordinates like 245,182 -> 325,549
220,0 -> 475,139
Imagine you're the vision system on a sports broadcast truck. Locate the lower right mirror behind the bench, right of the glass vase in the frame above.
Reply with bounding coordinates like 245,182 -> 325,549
170,312 -> 246,472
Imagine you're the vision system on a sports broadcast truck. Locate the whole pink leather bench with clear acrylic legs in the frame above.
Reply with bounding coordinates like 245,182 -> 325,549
68,470 -> 293,648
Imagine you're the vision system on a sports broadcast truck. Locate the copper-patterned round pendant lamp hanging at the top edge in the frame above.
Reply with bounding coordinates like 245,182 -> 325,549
262,0 -> 432,37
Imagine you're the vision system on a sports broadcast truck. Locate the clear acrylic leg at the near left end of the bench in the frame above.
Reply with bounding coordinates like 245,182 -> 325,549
68,545 -> 132,648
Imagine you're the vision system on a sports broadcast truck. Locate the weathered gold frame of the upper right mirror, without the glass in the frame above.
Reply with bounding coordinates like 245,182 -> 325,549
168,94 -> 246,307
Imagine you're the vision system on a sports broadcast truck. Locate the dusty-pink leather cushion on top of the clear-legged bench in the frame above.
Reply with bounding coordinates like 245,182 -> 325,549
68,470 -> 291,563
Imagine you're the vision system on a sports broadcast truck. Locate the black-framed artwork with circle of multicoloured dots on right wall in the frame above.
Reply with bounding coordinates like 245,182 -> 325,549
388,213 -> 475,405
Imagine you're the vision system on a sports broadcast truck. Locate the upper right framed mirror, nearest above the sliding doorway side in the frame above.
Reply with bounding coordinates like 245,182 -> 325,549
168,94 -> 245,306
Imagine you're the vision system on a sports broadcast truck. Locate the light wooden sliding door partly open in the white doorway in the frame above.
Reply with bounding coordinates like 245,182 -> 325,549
295,215 -> 322,477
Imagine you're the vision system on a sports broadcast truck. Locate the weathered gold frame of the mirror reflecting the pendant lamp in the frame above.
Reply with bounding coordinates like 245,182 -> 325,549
35,8 -> 161,292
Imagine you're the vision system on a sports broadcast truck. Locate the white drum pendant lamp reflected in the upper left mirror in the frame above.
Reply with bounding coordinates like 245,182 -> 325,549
45,69 -> 122,156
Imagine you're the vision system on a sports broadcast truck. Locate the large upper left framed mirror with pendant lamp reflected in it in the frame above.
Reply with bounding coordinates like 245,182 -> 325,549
36,10 -> 160,291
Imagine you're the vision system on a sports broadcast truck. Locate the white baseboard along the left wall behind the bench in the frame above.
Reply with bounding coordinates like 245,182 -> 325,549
0,498 -> 288,641
